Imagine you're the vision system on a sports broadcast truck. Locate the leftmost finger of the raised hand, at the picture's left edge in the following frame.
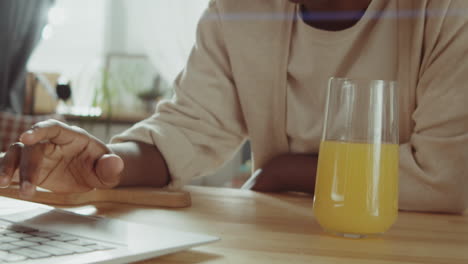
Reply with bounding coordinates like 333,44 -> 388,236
0,143 -> 24,187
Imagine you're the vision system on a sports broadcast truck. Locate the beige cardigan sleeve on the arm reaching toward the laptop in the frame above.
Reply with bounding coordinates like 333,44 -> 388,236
111,1 -> 246,188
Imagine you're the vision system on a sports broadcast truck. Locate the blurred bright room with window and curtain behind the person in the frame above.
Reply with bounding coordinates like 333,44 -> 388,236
0,0 -> 250,187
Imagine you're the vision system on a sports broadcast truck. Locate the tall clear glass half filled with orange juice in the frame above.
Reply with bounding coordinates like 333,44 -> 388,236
314,78 -> 399,238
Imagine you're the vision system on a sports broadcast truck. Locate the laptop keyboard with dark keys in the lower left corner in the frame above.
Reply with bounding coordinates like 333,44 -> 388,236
0,221 -> 113,263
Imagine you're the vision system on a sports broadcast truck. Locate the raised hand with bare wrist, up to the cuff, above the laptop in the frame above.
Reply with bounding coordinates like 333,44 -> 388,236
0,120 -> 169,198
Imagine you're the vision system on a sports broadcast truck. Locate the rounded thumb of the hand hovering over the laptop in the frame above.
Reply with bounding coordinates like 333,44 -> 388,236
95,154 -> 124,188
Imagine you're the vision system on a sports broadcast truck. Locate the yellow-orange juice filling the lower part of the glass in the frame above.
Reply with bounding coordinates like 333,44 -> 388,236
314,141 -> 399,235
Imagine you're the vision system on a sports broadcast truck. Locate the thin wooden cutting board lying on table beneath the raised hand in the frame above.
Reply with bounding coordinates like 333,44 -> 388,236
0,185 -> 191,208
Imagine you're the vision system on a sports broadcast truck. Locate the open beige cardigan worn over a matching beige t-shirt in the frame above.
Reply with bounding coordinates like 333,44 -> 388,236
113,0 -> 468,212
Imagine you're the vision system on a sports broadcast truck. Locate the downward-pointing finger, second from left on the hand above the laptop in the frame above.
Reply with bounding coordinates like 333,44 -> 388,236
19,144 -> 44,198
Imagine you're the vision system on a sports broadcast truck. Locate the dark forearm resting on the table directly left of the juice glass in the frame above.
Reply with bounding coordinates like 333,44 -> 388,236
251,154 -> 318,194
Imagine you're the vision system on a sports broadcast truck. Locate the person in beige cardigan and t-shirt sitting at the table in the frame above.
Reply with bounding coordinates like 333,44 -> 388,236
0,0 -> 468,213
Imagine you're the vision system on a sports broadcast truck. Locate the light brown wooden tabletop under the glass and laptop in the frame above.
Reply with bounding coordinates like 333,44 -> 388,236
68,186 -> 468,264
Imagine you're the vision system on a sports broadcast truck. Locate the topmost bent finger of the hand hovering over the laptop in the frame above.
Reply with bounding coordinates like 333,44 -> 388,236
20,119 -> 82,145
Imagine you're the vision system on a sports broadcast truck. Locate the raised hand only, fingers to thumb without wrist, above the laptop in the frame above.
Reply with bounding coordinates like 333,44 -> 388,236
0,120 -> 124,198
